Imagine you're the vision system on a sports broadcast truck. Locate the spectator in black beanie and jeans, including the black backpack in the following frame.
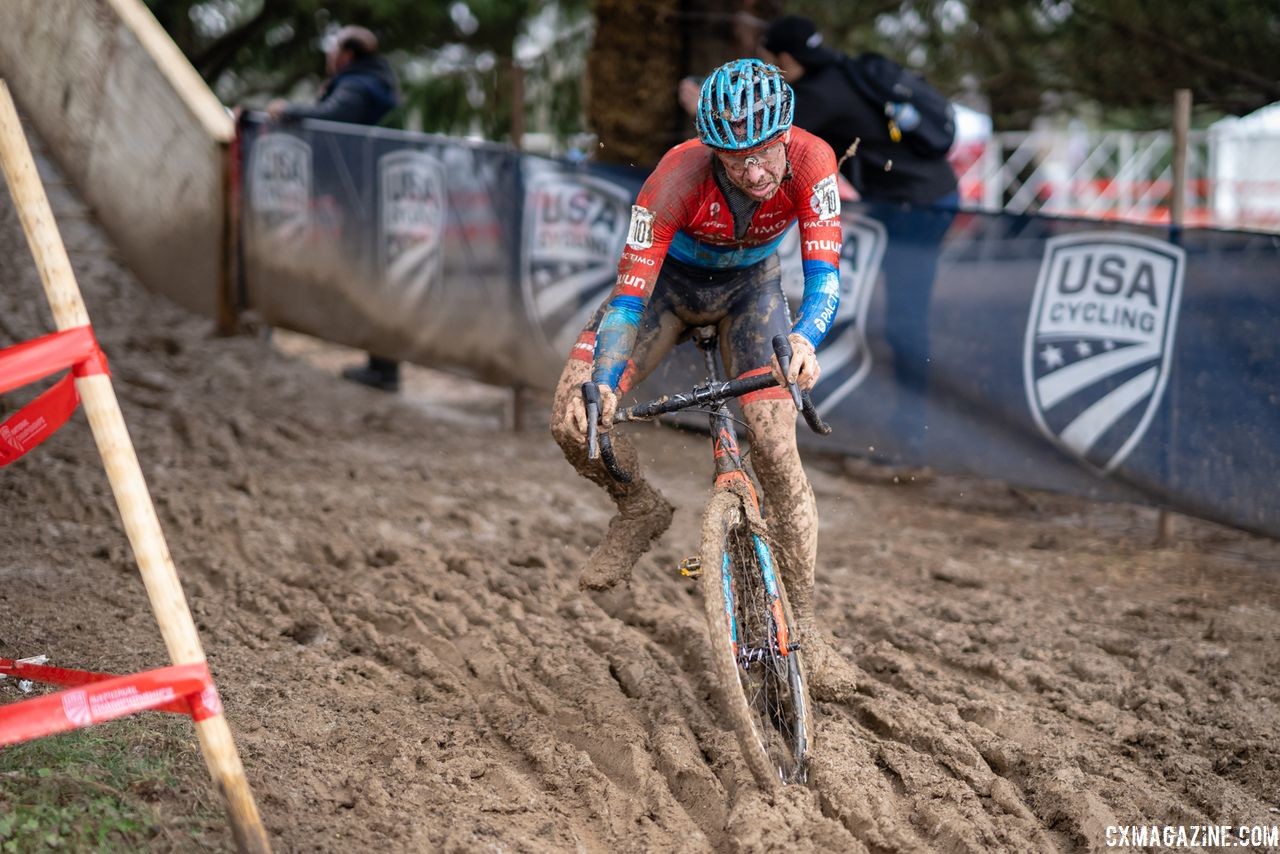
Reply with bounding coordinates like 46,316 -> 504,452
760,15 -> 960,465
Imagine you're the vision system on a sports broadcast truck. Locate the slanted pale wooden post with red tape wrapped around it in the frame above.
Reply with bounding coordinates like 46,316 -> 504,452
0,81 -> 271,853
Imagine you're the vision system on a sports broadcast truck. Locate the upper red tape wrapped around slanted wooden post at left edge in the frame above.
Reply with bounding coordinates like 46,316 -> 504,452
0,326 -> 109,469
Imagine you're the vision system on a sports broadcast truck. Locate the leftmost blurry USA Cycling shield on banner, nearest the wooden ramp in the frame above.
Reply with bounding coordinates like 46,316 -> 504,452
248,133 -> 311,239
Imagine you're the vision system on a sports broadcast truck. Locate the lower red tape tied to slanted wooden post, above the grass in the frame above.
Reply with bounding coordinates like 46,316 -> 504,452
0,658 -> 223,748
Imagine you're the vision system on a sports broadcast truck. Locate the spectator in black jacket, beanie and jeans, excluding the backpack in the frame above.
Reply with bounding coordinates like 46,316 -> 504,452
762,15 -> 959,463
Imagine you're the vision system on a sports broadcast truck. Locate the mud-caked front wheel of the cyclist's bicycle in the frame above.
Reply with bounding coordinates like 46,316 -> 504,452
701,490 -> 813,790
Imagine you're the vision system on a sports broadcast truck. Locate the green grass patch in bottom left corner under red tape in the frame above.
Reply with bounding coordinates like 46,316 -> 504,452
0,714 -> 229,854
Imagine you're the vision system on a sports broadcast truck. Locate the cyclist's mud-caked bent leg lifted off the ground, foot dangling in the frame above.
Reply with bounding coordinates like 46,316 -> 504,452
552,359 -> 673,590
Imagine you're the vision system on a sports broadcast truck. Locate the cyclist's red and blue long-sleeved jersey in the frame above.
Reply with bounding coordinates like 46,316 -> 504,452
593,128 -> 841,389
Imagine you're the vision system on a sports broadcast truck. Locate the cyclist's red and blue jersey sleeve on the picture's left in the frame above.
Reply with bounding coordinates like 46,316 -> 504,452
591,152 -> 685,391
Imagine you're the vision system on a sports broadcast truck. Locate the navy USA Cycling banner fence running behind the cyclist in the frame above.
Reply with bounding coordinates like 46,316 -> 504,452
239,120 -> 1280,535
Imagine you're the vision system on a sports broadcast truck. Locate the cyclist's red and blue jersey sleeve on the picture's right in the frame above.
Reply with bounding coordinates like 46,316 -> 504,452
791,134 -> 842,347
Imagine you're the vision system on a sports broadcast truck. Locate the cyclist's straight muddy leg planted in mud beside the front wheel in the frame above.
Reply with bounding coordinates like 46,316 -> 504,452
742,398 -> 856,702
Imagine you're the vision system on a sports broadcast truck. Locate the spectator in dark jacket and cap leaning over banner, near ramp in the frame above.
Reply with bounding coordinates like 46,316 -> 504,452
266,27 -> 399,392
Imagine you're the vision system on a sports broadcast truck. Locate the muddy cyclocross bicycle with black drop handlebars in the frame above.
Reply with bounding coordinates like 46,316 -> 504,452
582,326 -> 831,789
